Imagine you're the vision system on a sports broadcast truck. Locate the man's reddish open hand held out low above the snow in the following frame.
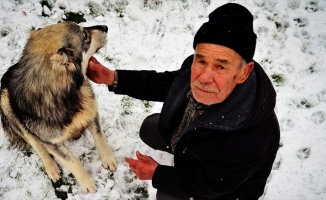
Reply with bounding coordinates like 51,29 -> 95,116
125,151 -> 159,180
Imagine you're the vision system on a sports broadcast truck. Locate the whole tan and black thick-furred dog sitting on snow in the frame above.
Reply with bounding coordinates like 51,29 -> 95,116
0,22 -> 117,192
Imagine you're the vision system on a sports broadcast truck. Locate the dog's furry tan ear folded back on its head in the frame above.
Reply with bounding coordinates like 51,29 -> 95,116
50,47 -> 76,71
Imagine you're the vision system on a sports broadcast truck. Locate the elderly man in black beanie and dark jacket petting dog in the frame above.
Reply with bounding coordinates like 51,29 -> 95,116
88,3 -> 280,200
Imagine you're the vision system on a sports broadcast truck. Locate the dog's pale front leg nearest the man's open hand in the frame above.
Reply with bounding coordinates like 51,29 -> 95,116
89,114 -> 117,171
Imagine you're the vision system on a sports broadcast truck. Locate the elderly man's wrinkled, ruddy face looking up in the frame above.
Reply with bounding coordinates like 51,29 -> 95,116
190,43 -> 254,105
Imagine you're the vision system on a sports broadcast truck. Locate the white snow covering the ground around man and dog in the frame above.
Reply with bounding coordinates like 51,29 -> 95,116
0,0 -> 326,200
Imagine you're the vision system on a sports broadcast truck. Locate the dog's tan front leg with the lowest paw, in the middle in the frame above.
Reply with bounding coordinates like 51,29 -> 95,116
41,143 -> 97,193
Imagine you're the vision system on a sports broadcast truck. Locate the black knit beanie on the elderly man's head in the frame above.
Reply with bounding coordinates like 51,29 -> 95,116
193,3 -> 256,62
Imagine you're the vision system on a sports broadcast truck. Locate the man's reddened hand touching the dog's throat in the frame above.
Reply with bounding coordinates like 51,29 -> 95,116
87,56 -> 114,86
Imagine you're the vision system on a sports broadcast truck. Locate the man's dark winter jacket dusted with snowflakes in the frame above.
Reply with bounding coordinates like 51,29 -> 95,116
115,56 -> 280,200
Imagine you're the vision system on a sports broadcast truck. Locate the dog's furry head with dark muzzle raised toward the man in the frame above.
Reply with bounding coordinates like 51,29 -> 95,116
20,22 -> 108,75
